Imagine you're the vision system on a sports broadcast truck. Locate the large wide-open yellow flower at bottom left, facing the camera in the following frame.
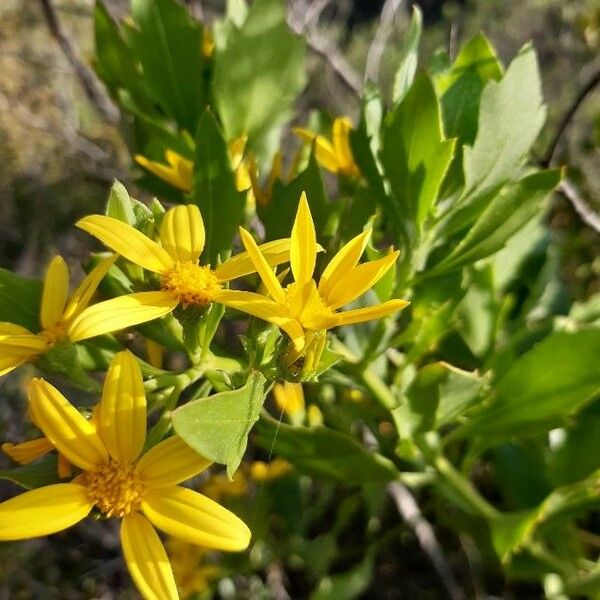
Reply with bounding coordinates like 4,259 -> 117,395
0,351 -> 251,600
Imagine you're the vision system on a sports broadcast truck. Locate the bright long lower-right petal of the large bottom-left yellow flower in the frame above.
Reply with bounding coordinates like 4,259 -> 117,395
142,486 -> 251,552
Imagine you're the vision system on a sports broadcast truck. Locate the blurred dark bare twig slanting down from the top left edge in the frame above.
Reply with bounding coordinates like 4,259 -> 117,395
40,0 -> 119,123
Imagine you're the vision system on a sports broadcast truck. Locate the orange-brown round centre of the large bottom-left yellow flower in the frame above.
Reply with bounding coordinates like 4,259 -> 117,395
85,461 -> 146,517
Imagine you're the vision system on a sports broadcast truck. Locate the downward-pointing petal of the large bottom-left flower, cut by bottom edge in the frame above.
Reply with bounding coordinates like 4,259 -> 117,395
121,513 -> 179,600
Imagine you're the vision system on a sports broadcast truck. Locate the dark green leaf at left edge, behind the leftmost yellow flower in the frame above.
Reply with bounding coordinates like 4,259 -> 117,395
0,269 -> 42,332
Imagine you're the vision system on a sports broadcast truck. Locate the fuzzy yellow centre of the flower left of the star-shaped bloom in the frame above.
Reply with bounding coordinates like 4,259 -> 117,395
161,261 -> 221,306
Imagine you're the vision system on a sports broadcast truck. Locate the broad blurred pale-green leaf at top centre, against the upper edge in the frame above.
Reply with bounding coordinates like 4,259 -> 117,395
213,0 -> 305,151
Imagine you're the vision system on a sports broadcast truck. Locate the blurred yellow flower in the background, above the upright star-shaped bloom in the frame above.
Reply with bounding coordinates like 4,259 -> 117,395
292,117 -> 360,177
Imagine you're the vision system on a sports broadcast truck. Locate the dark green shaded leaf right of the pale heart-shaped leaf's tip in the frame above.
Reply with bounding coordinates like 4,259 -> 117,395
257,414 -> 398,485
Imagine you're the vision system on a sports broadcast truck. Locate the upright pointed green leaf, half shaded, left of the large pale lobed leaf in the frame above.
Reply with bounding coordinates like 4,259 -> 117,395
381,72 -> 454,229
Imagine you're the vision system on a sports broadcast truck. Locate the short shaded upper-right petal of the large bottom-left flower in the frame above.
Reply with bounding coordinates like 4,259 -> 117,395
136,435 -> 212,487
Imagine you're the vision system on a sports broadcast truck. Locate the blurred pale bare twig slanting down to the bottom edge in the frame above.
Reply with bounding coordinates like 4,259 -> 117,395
387,481 -> 467,600
